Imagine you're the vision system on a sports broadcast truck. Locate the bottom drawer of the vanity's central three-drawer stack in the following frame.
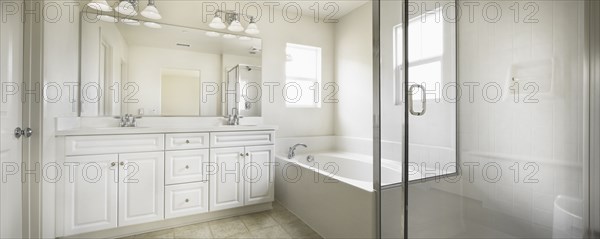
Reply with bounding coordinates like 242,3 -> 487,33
165,182 -> 208,218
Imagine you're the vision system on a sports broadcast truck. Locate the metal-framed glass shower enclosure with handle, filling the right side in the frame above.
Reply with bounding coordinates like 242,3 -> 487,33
373,0 -> 591,238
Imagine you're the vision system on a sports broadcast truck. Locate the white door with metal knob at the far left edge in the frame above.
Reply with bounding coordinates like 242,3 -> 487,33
0,1 -> 23,238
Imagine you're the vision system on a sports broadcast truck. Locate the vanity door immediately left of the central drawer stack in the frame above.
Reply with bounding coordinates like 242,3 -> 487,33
119,152 -> 164,226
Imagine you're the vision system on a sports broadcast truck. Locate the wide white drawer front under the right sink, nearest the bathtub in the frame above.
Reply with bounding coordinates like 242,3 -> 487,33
210,131 -> 275,148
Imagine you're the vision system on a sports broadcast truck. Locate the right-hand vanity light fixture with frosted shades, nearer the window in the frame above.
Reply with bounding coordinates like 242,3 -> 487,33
208,10 -> 260,35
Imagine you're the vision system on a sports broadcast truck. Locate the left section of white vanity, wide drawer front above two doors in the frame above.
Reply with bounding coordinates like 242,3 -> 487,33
64,134 -> 164,235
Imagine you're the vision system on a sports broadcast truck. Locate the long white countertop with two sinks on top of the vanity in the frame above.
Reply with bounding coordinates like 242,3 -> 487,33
55,125 -> 278,136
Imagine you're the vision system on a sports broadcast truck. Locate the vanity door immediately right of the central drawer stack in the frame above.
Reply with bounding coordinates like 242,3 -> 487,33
206,147 -> 244,211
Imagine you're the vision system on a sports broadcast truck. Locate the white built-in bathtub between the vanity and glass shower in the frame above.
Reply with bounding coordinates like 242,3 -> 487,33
275,152 -> 402,238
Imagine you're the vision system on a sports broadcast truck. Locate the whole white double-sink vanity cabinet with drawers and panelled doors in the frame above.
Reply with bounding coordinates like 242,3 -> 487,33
56,128 -> 274,237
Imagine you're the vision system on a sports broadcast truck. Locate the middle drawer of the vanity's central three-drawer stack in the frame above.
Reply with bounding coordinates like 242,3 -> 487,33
165,149 -> 209,185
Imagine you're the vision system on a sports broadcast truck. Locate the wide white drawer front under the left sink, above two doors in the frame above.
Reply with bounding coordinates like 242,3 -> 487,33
65,134 -> 165,155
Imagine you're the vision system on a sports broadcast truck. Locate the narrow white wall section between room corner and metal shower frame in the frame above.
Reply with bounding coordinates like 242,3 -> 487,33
334,3 -> 373,139
